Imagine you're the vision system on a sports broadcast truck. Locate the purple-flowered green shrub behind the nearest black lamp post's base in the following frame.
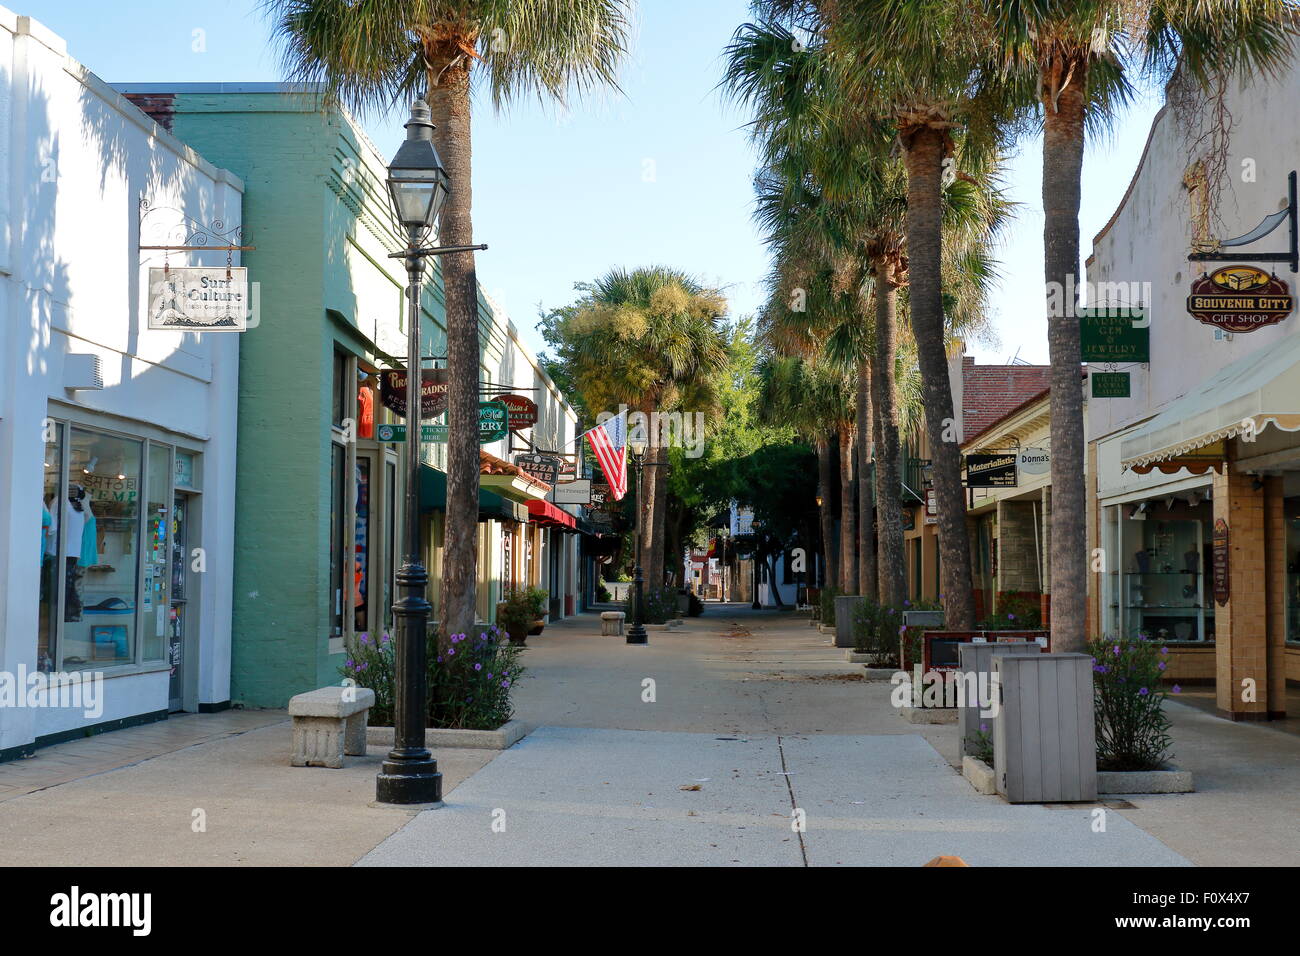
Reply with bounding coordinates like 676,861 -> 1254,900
339,626 -> 524,730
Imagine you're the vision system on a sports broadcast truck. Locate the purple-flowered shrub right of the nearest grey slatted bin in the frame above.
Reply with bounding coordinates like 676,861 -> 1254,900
1088,635 -> 1178,770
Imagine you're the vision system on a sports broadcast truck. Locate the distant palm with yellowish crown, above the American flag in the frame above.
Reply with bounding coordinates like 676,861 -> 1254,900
556,267 -> 731,588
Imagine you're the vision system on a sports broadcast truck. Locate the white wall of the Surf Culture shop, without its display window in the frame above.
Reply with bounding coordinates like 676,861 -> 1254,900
0,8 -> 243,749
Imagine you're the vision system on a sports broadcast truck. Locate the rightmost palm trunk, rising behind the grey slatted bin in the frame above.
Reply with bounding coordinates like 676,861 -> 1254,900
1043,61 -> 1088,653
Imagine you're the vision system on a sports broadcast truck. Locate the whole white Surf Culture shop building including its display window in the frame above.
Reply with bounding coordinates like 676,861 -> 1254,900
0,8 -> 243,760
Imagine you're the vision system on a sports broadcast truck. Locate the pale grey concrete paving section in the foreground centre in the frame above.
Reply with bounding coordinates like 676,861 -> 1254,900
361,727 -> 1187,866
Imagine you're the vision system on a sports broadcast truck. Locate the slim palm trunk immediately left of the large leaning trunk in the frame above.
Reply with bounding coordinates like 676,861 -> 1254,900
871,261 -> 907,607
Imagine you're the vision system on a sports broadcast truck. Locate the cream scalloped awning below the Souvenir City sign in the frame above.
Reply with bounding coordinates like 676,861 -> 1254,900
1119,334 -> 1300,475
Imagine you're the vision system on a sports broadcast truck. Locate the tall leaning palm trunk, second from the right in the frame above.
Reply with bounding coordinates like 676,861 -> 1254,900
904,126 -> 975,631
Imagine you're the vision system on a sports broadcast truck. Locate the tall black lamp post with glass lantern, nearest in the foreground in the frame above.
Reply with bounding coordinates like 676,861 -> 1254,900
374,100 -> 486,804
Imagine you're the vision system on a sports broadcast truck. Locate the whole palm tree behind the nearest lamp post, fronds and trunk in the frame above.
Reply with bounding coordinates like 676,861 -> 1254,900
265,0 -> 628,640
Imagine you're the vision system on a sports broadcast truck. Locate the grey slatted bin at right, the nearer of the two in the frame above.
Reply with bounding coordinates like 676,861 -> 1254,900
993,654 -> 1097,804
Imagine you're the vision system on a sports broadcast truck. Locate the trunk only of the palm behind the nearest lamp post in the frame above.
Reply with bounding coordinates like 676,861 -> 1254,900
428,57 -> 480,646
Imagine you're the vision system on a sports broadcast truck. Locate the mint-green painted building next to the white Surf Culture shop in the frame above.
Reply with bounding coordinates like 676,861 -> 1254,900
118,83 -> 576,706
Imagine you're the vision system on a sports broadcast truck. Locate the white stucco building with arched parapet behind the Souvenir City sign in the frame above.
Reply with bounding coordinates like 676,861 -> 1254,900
1087,65 -> 1300,719
